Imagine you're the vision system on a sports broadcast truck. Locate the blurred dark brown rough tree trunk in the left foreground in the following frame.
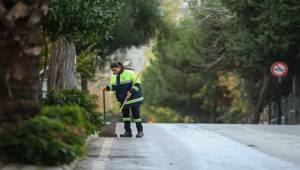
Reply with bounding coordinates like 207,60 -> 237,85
0,0 -> 48,125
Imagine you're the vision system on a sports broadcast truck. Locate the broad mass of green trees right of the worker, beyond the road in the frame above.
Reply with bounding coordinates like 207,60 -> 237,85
144,0 -> 300,123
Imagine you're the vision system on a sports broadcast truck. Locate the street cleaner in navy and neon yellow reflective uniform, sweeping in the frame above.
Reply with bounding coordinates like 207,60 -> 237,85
102,62 -> 144,138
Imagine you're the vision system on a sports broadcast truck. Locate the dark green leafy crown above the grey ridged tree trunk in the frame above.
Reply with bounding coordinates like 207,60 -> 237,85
43,0 -> 124,83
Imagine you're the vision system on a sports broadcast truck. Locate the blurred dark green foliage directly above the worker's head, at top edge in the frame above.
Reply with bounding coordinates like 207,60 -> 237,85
99,0 -> 163,56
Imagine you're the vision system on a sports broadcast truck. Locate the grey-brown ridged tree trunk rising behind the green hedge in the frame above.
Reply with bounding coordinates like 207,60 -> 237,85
48,36 -> 77,91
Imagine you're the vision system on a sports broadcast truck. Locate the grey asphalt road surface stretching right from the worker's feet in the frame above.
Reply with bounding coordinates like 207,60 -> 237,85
75,124 -> 300,170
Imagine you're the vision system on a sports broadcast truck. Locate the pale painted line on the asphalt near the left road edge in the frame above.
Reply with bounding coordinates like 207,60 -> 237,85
93,138 -> 113,170
